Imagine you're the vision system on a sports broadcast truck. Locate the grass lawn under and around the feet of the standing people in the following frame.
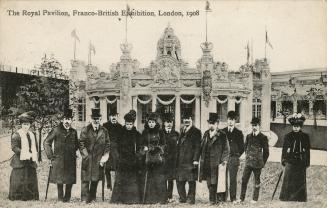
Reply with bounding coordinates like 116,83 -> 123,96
0,152 -> 327,208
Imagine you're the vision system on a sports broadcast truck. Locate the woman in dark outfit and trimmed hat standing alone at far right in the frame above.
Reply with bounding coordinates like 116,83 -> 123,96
279,114 -> 310,202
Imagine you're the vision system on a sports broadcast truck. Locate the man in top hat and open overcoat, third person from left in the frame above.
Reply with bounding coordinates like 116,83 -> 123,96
80,108 -> 110,203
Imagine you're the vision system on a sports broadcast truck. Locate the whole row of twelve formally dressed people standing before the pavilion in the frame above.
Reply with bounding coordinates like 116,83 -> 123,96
9,109 -> 310,204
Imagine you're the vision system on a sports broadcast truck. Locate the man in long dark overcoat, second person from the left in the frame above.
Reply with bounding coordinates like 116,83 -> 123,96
43,109 -> 79,202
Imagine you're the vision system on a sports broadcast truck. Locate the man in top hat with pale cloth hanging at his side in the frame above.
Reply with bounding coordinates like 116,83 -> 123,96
199,113 -> 229,204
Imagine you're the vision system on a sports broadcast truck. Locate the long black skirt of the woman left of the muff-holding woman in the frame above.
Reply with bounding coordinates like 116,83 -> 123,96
111,170 -> 141,204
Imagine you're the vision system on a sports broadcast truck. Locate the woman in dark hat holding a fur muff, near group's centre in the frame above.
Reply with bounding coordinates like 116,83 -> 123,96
141,113 -> 167,204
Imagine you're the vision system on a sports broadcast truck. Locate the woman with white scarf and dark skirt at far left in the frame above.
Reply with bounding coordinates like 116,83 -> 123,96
8,112 -> 39,201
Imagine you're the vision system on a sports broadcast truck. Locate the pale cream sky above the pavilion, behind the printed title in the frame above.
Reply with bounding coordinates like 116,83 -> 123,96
0,0 -> 327,72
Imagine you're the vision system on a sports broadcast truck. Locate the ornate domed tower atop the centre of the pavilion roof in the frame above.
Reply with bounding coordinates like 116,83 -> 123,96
157,24 -> 182,61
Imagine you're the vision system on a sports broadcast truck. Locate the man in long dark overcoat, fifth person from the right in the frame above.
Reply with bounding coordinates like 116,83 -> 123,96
176,109 -> 201,204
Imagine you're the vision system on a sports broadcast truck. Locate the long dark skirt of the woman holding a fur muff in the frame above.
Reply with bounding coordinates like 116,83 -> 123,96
141,166 -> 167,204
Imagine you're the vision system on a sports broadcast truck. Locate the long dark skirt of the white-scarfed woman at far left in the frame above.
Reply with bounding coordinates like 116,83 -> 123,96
8,166 -> 39,201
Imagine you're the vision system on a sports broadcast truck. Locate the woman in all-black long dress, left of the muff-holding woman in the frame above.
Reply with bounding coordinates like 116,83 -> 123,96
111,113 -> 142,204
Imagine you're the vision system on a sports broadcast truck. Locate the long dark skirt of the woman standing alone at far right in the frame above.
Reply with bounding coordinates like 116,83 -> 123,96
279,163 -> 307,202
